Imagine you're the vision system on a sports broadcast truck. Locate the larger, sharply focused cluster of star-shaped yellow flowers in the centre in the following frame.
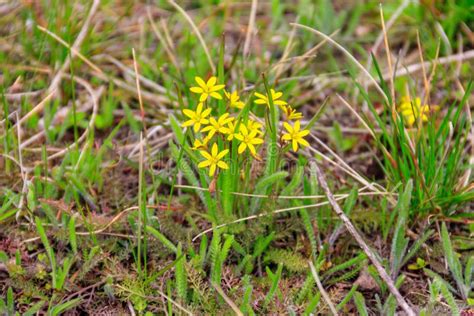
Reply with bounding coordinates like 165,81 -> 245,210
182,77 -> 309,177
